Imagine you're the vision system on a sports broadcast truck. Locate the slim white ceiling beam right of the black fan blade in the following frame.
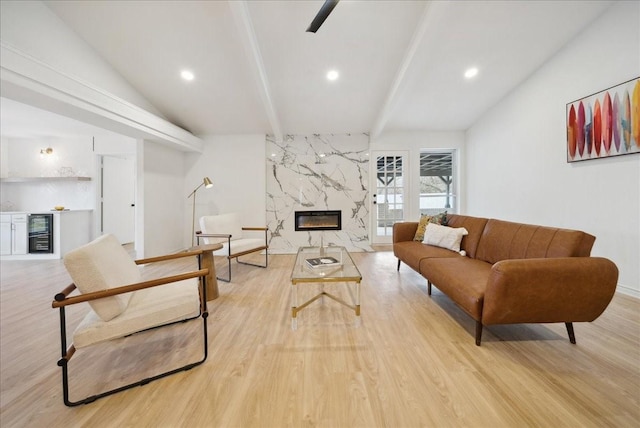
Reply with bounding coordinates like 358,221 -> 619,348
370,1 -> 433,138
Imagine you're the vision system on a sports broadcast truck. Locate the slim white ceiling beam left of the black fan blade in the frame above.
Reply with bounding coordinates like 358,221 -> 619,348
229,0 -> 283,142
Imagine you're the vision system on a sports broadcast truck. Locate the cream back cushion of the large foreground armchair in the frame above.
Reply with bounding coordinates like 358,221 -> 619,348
64,235 -> 140,321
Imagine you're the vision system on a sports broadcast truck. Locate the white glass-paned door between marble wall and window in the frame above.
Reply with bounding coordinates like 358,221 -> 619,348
371,151 -> 408,244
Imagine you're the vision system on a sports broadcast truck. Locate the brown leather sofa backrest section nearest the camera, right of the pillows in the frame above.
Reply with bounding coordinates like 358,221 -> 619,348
476,219 -> 588,264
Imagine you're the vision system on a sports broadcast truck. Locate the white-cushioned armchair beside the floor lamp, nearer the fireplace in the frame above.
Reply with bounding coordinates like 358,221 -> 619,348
196,213 -> 269,282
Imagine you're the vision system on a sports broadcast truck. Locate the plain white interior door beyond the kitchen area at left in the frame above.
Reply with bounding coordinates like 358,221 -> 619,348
101,156 -> 135,244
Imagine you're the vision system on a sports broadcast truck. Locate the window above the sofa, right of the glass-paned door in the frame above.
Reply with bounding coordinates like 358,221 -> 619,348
420,150 -> 458,215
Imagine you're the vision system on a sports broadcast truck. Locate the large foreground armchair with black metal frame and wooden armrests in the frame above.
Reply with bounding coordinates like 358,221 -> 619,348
52,235 -> 209,406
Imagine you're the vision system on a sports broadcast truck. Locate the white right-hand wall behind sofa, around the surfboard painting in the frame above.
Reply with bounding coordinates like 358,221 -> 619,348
466,2 -> 640,296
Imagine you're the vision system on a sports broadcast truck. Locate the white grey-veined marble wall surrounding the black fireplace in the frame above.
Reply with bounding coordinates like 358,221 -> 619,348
266,134 -> 373,254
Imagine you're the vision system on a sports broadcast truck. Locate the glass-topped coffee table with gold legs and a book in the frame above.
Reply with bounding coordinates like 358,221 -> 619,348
291,247 -> 362,330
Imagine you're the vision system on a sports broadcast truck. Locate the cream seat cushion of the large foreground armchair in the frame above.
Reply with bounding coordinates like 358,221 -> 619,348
73,278 -> 200,348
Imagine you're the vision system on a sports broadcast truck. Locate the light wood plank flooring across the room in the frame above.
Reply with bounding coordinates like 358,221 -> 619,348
0,251 -> 640,428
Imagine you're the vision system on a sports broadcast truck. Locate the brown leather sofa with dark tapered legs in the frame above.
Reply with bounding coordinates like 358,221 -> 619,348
393,214 -> 618,346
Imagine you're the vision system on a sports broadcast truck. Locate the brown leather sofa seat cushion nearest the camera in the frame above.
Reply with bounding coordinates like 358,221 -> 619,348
419,256 -> 491,321
